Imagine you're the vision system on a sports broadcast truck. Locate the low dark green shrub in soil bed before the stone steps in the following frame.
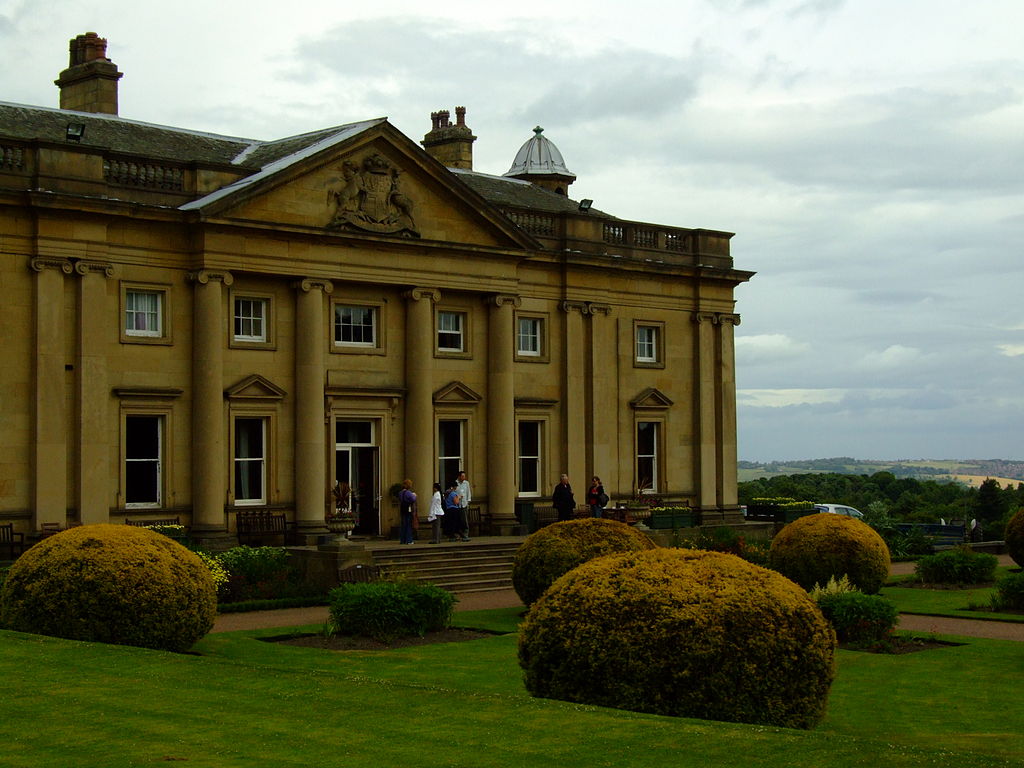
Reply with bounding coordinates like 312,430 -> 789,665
329,582 -> 456,643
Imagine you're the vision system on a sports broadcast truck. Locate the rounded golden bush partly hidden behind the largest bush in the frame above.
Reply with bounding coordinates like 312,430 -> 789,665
512,517 -> 655,605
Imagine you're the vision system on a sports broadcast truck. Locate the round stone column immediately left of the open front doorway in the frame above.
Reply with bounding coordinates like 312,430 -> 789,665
295,279 -> 334,539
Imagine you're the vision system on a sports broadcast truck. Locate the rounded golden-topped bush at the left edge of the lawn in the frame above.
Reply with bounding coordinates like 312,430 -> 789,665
0,524 -> 217,651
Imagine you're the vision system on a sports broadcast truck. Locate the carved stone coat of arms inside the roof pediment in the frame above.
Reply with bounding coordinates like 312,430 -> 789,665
327,153 -> 420,238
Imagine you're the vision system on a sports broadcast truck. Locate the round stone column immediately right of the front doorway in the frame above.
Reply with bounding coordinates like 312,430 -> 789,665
397,288 -> 441,505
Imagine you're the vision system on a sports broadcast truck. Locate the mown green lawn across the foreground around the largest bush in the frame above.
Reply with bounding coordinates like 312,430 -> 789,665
0,609 -> 1024,768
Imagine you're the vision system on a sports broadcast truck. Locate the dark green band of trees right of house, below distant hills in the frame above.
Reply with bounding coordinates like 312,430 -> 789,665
739,472 -> 1024,539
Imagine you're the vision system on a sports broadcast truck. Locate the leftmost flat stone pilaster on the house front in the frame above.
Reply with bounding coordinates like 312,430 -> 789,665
30,258 -> 72,529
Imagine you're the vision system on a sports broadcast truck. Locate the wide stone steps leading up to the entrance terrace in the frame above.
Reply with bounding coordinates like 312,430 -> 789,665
373,539 -> 521,593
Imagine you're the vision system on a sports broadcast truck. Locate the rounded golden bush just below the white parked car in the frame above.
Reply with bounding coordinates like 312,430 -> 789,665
769,513 -> 891,595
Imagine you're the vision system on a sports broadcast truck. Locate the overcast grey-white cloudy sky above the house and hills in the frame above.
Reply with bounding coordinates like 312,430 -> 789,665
0,0 -> 1024,461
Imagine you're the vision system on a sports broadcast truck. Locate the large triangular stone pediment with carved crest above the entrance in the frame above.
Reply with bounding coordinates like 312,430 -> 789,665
183,119 -> 536,249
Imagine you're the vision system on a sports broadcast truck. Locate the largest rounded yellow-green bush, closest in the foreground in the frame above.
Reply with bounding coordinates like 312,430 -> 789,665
519,549 -> 836,728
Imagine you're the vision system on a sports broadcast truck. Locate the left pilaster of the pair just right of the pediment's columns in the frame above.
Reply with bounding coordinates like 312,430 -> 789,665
557,301 -> 590,493
